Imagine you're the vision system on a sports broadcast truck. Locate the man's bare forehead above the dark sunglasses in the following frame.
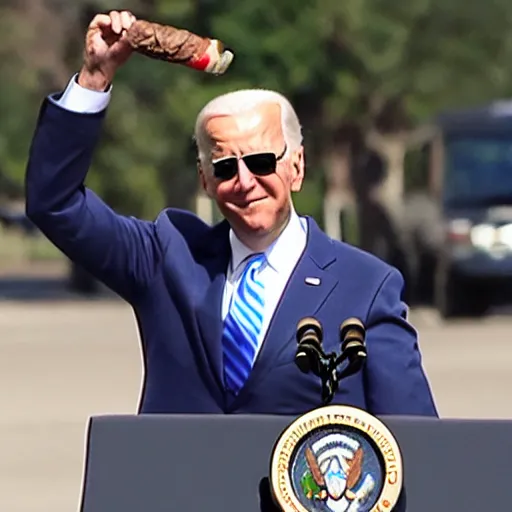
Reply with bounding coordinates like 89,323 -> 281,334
204,103 -> 284,151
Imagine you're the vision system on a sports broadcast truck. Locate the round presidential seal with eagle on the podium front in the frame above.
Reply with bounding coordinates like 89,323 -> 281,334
270,405 -> 403,512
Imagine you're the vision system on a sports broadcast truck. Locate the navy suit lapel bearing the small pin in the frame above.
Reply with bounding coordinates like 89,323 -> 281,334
236,218 -> 338,402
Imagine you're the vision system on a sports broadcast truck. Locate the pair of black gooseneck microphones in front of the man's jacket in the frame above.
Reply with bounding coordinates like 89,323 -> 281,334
295,317 -> 367,405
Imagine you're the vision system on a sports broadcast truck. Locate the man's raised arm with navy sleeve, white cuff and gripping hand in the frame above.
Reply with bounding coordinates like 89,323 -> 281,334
26,13 -> 159,300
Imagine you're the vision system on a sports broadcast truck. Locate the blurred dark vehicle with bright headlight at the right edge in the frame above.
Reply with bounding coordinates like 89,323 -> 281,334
419,102 -> 512,318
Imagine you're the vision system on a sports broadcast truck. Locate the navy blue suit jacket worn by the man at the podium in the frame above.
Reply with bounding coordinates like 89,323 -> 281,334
26,100 -> 437,416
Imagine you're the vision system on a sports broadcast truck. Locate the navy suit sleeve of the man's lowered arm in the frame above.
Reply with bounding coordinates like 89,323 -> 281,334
365,269 -> 438,417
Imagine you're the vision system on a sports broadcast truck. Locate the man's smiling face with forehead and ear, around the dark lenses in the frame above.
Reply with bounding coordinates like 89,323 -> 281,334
200,104 -> 304,242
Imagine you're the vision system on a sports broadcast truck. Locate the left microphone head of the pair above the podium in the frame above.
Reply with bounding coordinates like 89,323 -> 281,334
295,317 -> 323,377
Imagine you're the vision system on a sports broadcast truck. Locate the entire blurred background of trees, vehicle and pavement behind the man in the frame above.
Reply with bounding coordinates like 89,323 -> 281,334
0,0 -> 512,512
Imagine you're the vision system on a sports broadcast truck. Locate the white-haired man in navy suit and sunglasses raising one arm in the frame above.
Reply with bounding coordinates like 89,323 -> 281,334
26,12 -> 437,416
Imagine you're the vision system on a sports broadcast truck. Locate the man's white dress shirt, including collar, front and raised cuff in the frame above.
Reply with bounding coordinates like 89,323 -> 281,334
54,75 -> 307,358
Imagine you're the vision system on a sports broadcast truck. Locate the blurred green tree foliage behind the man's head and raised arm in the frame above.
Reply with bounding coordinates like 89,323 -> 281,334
0,0 -> 512,223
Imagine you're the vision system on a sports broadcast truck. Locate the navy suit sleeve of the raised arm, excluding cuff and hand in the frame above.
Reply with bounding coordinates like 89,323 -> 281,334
25,98 -> 159,301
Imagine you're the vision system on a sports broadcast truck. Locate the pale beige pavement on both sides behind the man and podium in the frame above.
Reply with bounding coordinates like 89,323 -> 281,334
0,301 -> 512,512
